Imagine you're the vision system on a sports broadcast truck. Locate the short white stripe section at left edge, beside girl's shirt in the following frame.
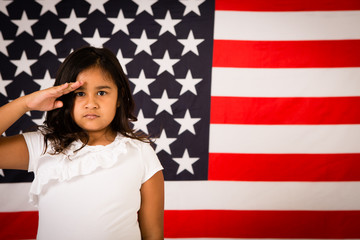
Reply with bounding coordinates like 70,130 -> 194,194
0,183 -> 37,212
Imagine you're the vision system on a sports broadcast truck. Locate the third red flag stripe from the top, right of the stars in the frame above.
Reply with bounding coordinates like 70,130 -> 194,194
210,97 -> 360,124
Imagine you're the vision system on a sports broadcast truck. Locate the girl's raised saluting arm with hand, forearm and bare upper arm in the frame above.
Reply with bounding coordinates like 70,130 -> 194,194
0,82 -> 83,170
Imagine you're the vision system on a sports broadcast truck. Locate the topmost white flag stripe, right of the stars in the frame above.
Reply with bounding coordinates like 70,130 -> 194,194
214,11 -> 360,41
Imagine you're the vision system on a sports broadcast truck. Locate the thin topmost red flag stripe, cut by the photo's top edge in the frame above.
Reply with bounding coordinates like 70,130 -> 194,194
215,0 -> 360,11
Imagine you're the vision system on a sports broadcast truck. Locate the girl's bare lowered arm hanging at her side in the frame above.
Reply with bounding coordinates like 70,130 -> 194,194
139,171 -> 164,240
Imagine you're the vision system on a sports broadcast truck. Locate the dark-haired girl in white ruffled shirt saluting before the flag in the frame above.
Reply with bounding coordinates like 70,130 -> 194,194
0,47 -> 164,240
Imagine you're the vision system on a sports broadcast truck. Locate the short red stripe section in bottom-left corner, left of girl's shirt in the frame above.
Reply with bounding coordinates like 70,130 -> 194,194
0,212 -> 38,239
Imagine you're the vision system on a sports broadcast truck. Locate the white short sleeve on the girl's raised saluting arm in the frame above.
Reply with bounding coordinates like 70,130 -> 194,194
23,132 -> 45,172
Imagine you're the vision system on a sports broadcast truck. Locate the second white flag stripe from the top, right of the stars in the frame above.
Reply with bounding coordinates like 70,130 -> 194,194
211,67 -> 360,97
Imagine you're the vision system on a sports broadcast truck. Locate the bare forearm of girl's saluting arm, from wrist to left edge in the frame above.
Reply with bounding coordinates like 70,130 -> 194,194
0,97 -> 29,134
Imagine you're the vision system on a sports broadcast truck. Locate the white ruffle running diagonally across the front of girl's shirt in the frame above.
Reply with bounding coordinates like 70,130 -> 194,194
30,134 -> 140,205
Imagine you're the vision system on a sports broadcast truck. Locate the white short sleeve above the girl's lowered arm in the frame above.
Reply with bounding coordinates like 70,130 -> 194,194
141,143 -> 164,183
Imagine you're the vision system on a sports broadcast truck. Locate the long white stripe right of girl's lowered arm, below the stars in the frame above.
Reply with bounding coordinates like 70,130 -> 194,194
165,181 -> 360,210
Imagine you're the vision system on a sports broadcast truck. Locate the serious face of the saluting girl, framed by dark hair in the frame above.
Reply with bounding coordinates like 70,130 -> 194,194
72,67 -> 119,139
